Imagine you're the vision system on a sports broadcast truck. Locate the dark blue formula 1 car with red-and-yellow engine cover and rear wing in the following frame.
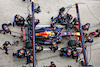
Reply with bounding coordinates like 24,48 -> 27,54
22,23 -> 80,45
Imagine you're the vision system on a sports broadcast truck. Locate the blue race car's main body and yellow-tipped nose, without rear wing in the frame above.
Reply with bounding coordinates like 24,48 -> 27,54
35,27 -> 80,45
